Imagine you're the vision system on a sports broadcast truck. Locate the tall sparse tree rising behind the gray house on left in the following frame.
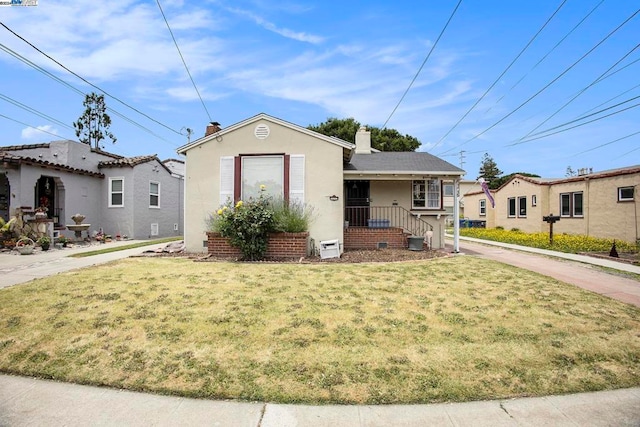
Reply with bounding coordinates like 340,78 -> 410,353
73,92 -> 116,149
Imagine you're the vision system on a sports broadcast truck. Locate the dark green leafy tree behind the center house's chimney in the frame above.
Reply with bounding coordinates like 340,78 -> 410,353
307,117 -> 420,151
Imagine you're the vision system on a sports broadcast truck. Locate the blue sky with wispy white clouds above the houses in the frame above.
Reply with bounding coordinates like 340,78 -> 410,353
0,0 -> 640,179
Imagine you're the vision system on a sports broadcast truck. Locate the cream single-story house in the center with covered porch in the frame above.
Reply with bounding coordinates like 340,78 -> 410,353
178,114 -> 464,252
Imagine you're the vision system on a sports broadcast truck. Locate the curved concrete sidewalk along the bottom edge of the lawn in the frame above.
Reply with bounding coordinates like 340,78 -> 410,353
0,375 -> 640,427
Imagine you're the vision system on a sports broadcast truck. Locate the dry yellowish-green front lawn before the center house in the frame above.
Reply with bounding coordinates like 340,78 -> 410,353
0,257 -> 640,404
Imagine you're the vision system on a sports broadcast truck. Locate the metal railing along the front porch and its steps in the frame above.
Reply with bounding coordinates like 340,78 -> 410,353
344,206 -> 433,236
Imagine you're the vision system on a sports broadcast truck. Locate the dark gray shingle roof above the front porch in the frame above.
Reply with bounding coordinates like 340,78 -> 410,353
344,152 -> 464,175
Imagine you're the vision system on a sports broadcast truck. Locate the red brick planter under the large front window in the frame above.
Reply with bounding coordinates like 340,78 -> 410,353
207,232 -> 309,259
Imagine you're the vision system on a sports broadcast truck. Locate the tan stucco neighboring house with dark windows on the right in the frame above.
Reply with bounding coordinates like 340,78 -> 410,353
465,166 -> 640,243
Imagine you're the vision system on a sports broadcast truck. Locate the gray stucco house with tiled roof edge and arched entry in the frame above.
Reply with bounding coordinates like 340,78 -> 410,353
0,141 -> 184,239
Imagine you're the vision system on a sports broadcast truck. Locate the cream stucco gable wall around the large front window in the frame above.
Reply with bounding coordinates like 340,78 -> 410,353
185,119 -> 344,252
